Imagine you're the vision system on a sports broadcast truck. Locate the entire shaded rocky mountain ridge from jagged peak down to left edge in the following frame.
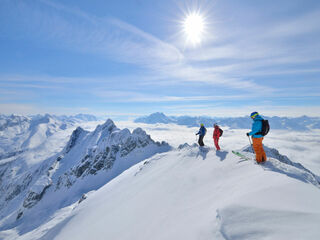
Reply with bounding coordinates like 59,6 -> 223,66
0,119 -> 171,233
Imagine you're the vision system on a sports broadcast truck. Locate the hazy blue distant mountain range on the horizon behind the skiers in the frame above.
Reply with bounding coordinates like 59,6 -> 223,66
135,112 -> 320,131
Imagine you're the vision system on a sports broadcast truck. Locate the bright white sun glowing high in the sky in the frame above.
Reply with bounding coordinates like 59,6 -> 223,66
183,13 -> 205,45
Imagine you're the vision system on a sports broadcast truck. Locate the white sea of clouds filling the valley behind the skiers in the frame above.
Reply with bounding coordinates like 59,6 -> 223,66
116,122 -> 320,175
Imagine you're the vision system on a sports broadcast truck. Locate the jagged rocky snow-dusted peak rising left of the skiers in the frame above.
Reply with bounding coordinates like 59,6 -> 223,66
53,119 -> 170,202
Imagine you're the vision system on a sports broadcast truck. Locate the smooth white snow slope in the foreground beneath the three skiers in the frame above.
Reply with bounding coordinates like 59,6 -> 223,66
0,122 -> 320,240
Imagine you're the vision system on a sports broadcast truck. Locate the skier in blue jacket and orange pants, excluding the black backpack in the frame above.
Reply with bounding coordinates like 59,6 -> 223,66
247,112 -> 267,163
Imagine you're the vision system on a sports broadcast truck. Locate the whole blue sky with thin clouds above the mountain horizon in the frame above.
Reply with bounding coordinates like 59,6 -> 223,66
0,0 -> 320,118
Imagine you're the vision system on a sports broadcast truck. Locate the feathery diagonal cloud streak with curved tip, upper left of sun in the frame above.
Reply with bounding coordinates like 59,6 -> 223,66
37,0 -> 183,67
